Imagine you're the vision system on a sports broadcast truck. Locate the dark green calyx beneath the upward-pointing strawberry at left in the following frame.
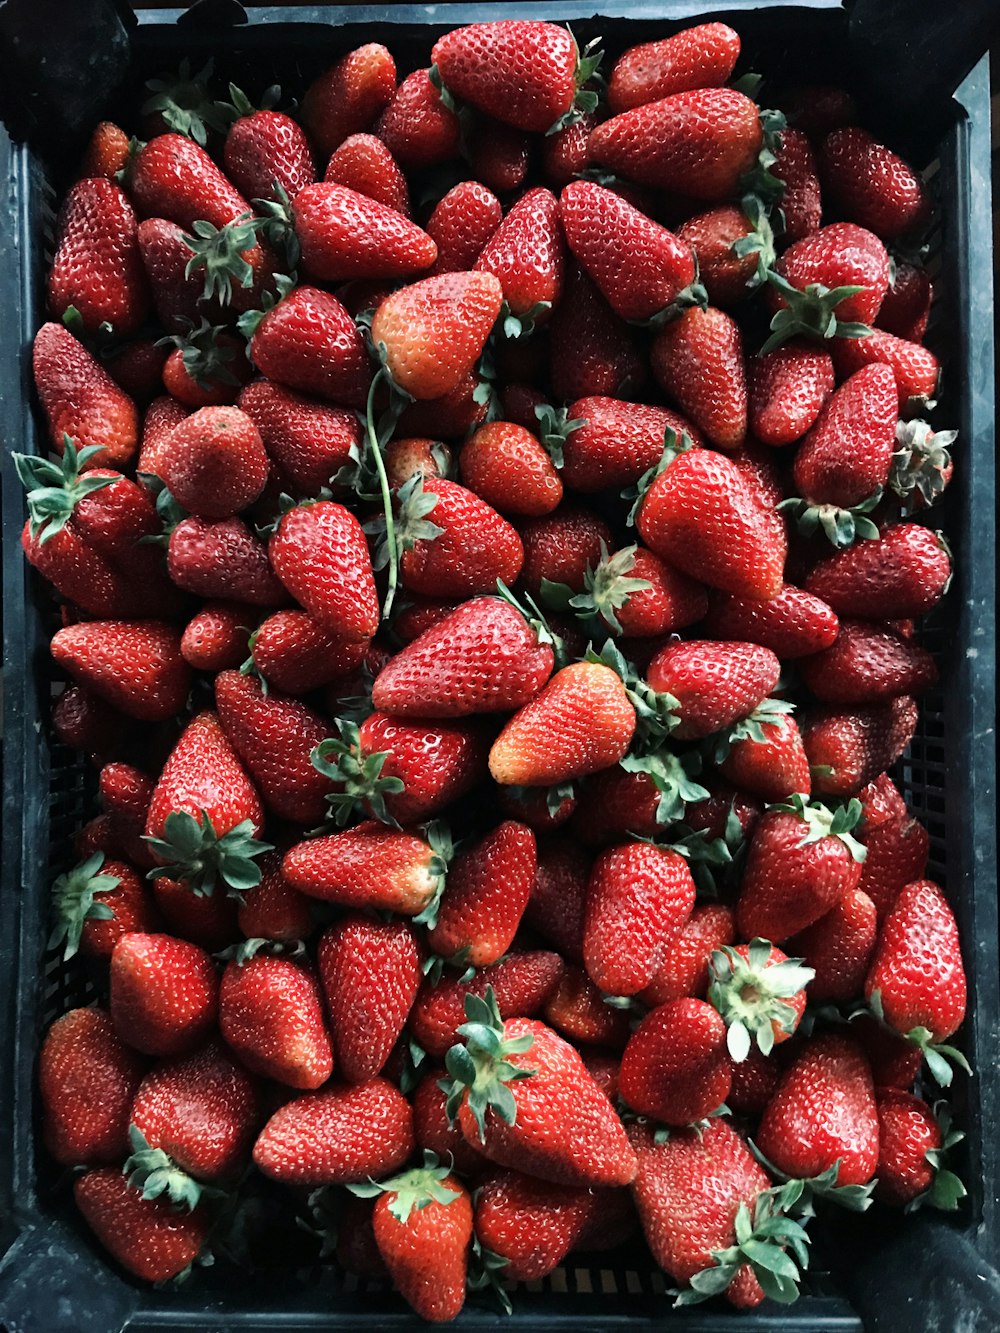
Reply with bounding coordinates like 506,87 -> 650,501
144,810 -> 273,898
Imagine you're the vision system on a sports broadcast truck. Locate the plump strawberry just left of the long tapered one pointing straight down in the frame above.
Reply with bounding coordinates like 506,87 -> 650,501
219,940 -> 333,1089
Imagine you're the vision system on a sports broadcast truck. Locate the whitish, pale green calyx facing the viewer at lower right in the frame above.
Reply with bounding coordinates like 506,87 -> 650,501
708,940 -> 816,1064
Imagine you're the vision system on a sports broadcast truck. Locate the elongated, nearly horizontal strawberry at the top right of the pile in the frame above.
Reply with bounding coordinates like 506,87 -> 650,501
608,23 -> 740,116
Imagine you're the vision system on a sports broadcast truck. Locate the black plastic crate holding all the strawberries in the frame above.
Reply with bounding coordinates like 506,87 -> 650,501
0,0 -> 1000,1333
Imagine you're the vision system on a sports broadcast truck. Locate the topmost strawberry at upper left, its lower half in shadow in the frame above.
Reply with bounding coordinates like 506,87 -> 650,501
301,41 -> 396,161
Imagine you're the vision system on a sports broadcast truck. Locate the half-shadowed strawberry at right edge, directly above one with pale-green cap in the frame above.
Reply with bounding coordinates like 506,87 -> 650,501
801,694 -> 917,796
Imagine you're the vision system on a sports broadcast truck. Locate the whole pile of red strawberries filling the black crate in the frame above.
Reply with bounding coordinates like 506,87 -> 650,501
17,21 -> 965,1320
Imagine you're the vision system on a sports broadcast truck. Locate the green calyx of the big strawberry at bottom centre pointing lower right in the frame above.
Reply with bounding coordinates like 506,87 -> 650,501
440,986 -> 537,1142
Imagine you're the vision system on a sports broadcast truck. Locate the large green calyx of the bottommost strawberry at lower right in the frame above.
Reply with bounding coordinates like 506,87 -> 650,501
673,1189 -> 809,1306
